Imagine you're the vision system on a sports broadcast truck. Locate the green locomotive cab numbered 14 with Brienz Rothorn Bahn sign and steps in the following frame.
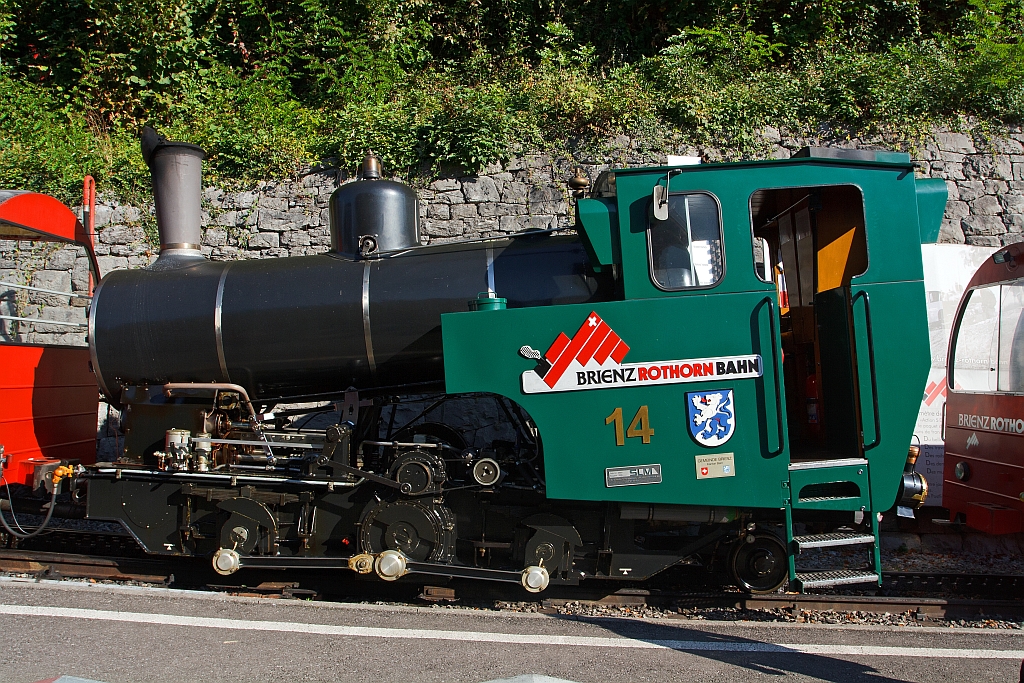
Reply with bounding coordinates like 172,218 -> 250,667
443,150 -> 941,587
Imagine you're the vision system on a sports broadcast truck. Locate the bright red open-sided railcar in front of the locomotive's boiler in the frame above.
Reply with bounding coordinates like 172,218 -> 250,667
0,178 -> 99,488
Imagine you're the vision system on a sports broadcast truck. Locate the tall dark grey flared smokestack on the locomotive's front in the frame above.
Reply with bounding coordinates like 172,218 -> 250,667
141,126 -> 206,264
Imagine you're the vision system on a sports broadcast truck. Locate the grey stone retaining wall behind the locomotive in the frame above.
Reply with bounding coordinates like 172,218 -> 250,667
0,128 -> 1024,352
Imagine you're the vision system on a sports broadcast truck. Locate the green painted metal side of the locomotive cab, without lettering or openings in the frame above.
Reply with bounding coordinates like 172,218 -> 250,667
441,156 -> 934,510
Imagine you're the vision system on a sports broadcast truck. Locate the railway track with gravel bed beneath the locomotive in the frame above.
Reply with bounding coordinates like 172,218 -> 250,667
0,549 -> 1024,621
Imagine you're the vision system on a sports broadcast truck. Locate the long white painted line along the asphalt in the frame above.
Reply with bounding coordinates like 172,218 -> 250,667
0,604 -> 1024,659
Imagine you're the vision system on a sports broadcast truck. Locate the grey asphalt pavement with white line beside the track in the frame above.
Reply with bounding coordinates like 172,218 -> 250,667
0,579 -> 1024,683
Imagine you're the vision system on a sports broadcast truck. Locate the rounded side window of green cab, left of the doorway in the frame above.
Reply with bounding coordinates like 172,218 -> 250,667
647,193 -> 725,291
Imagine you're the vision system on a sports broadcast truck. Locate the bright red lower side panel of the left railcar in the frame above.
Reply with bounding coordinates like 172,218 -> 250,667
0,344 -> 99,485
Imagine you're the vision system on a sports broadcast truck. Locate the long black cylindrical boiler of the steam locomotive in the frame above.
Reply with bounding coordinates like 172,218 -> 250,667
90,232 -> 612,400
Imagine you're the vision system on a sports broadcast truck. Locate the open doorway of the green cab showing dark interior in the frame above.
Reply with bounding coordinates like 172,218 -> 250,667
751,185 -> 870,463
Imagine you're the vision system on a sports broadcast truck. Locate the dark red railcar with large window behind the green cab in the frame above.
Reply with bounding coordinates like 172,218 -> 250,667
942,245 -> 1024,533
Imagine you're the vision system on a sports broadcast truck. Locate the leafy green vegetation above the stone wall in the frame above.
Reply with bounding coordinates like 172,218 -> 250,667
0,0 -> 1024,198
